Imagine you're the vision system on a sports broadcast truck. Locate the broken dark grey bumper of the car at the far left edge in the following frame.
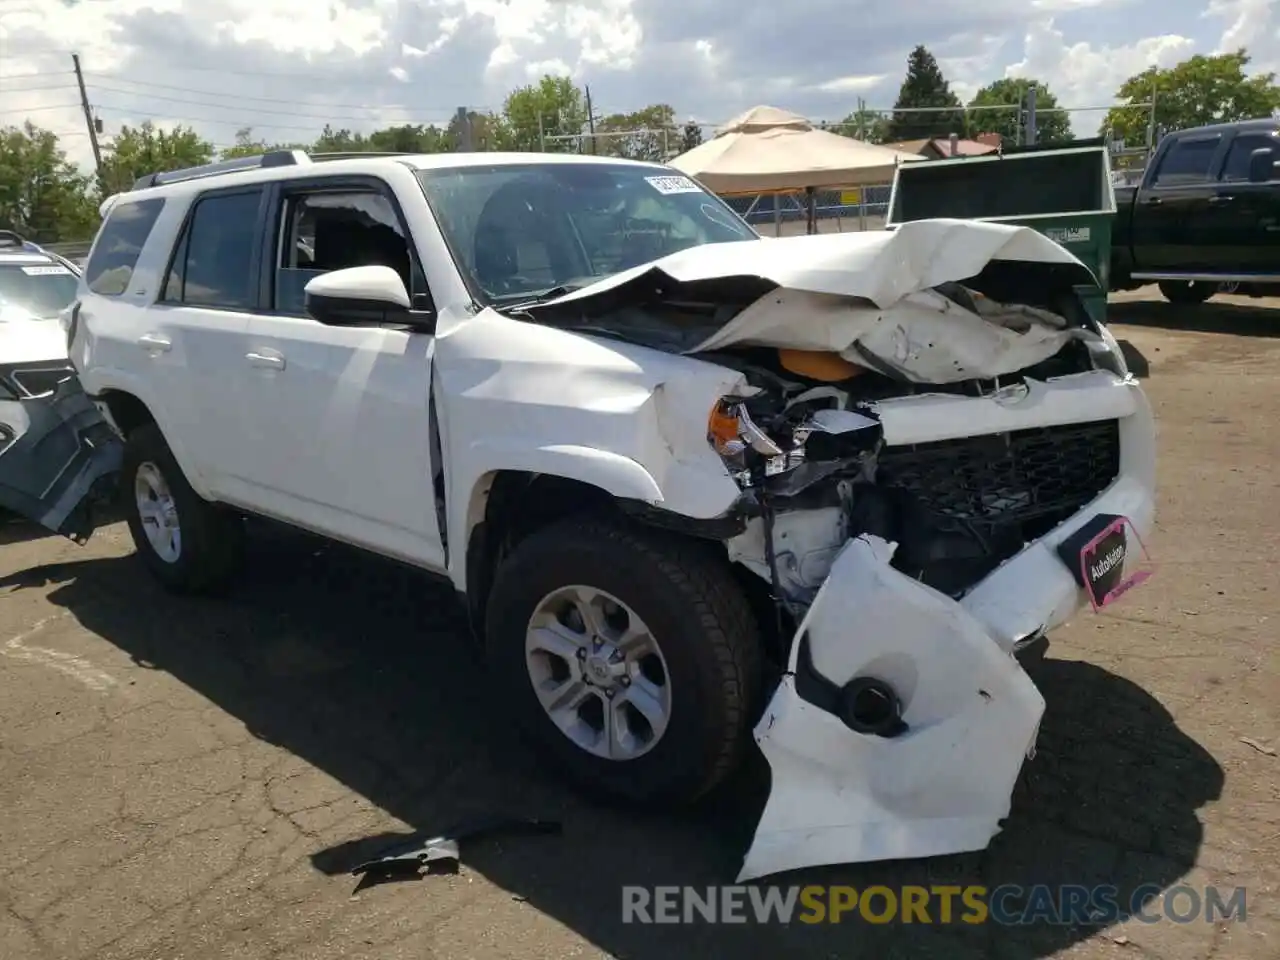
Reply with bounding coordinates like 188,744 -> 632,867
0,376 -> 124,544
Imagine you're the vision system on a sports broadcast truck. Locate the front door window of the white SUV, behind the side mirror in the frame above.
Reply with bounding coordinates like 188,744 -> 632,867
273,189 -> 426,316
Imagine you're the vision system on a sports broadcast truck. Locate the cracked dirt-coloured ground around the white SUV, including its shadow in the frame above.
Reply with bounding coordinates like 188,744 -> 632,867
0,291 -> 1280,960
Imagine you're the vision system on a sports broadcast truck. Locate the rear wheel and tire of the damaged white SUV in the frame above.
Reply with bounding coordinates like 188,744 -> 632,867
120,424 -> 244,594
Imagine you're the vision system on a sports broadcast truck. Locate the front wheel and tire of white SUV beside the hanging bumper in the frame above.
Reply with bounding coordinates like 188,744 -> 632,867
486,518 -> 762,806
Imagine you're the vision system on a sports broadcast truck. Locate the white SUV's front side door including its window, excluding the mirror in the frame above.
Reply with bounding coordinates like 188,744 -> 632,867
243,177 -> 444,570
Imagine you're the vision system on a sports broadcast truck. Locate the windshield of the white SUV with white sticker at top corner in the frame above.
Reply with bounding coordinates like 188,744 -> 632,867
419,163 -> 759,305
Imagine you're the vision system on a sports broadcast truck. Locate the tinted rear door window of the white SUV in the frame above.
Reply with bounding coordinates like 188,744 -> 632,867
164,189 -> 262,310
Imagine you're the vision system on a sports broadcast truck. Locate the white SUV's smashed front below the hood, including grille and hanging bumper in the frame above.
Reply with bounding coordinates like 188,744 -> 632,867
708,289 -> 1153,879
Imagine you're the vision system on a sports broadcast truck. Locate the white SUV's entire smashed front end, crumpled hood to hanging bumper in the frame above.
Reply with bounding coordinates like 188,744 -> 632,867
519,221 -> 1155,879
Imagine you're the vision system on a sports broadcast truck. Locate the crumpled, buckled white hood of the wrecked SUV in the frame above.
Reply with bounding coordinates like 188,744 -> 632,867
519,219 -> 1097,383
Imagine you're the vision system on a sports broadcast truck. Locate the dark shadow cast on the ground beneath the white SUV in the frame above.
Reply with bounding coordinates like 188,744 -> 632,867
0,535 -> 1222,960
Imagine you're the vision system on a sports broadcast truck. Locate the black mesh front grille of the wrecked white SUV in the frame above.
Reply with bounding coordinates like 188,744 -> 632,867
877,420 -> 1120,543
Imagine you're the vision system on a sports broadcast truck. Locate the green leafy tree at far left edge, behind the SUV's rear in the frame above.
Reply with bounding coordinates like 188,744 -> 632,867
0,122 -> 97,243
